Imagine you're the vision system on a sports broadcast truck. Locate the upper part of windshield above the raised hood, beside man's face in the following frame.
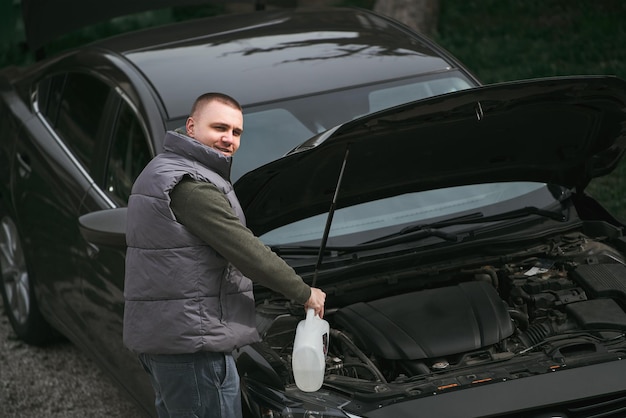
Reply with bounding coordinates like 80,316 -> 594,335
231,71 -> 472,182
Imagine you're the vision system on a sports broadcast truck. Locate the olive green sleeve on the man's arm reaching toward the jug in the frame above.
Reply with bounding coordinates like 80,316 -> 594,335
170,177 -> 311,304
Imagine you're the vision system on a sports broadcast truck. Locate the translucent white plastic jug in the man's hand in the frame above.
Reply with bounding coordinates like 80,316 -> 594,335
291,309 -> 330,392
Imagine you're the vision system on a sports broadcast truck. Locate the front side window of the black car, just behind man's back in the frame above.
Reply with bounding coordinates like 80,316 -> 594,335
105,100 -> 151,205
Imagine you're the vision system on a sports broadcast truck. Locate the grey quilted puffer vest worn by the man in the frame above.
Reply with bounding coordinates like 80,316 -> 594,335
124,132 -> 259,354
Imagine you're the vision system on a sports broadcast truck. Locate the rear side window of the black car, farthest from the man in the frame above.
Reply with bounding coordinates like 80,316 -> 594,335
39,73 -> 111,172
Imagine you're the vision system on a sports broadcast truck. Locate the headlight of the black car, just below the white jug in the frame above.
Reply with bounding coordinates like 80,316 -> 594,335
242,382 -> 359,418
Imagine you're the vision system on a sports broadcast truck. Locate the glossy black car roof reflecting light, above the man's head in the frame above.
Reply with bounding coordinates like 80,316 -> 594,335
86,8 -> 472,120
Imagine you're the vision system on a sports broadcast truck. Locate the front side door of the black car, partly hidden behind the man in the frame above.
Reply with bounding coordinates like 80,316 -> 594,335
80,92 -> 154,404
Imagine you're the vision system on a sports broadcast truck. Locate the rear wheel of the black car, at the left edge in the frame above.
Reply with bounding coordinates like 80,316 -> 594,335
0,216 -> 55,345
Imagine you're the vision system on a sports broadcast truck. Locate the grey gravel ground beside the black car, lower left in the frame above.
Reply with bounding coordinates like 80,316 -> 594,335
0,298 -> 141,418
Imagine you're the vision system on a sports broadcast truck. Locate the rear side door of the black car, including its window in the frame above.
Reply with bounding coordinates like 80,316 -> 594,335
13,72 -> 111,336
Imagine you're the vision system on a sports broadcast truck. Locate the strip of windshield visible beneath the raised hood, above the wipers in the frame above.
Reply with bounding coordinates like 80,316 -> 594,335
260,182 -> 555,246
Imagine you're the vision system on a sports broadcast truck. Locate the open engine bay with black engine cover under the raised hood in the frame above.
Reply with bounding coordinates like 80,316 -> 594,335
252,233 -> 626,398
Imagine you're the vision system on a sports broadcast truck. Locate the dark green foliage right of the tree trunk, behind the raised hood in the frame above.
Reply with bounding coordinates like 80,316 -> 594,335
434,0 -> 626,221
